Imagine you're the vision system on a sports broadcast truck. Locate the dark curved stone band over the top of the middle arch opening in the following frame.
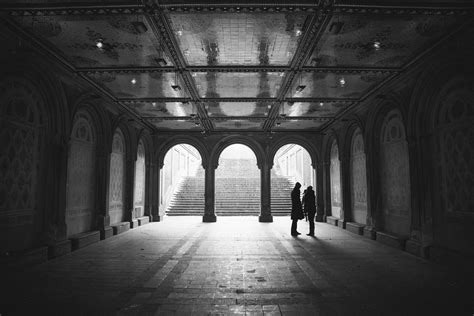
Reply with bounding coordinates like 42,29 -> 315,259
210,135 -> 265,169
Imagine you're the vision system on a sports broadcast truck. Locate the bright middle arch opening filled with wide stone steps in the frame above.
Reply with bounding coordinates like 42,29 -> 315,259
215,144 -> 260,216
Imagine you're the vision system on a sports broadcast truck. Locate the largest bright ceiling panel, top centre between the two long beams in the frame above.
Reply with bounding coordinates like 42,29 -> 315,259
170,12 -> 308,66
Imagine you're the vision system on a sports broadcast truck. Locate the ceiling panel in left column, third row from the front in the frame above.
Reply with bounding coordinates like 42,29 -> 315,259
125,102 -> 196,117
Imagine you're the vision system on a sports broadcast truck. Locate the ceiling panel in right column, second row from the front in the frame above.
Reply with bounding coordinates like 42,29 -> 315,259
287,72 -> 388,99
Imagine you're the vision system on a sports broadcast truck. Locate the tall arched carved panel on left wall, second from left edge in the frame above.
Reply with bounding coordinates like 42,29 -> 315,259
66,113 -> 96,236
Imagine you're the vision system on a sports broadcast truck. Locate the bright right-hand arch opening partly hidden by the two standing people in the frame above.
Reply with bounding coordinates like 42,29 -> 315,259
270,144 -> 316,216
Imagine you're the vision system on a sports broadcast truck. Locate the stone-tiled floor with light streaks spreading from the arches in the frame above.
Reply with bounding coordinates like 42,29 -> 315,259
0,217 -> 473,316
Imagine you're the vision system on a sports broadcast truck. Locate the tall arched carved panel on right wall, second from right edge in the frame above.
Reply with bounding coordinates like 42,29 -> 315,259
380,111 -> 411,236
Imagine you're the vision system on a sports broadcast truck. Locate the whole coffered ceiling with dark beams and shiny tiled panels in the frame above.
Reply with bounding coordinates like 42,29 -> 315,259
2,1 -> 472,133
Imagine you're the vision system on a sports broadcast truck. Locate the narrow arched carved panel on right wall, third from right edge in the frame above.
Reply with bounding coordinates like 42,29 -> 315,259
351,129 -> 367,224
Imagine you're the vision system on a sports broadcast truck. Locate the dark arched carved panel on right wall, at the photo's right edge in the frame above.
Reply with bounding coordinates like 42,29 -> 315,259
434,89 -> 474,253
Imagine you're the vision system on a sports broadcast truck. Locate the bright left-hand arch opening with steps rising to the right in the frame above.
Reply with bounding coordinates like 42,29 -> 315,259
159,144 -> 204,216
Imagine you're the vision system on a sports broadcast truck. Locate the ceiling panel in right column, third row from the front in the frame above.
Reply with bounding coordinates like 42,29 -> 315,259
282,102 -> 352,117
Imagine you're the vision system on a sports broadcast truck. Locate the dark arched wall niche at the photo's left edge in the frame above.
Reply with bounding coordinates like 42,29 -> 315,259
0,74 -> 58,251
